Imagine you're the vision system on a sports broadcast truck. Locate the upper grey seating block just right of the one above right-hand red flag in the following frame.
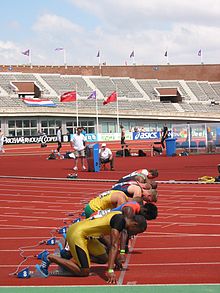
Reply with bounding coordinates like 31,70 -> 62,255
112,78 -> 143,99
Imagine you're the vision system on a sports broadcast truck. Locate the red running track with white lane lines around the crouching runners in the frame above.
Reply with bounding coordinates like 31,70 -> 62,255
0,177 -> 220,286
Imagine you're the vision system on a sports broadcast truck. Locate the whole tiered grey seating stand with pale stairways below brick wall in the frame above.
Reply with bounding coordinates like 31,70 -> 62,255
0,72 -> 220,118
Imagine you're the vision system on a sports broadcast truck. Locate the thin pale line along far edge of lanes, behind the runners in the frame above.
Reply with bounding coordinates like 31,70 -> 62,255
0,175 -> 220,185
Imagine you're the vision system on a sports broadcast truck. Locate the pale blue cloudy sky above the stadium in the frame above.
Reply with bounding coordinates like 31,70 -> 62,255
0,0 -> 220,65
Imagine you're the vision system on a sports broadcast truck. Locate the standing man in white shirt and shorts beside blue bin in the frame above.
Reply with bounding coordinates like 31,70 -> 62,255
70,127 -> 86,171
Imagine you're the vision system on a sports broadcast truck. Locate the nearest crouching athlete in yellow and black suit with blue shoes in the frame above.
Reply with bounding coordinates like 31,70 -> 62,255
36,212 -> 147,284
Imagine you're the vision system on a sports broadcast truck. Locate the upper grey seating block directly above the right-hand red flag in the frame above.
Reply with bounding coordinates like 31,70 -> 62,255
90,77 -> 118,97
